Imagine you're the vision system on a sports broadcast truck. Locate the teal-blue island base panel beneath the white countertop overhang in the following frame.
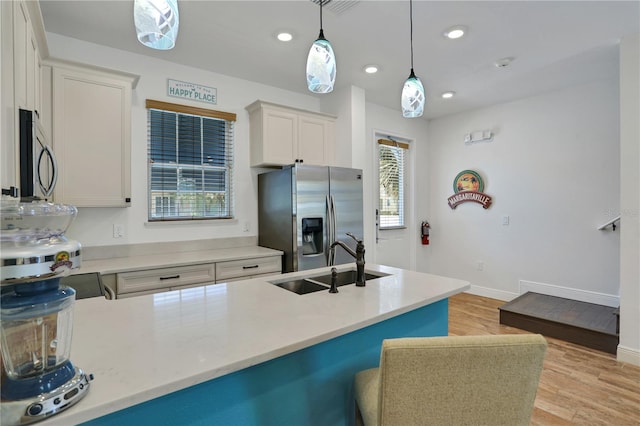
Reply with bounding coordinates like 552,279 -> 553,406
85,299 -> 448,426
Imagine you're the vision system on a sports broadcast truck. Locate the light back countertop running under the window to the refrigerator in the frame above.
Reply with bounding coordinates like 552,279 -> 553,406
73,246 -> 282,275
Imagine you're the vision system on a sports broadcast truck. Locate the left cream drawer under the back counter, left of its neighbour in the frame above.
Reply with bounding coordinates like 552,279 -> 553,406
116,263 -> 216,294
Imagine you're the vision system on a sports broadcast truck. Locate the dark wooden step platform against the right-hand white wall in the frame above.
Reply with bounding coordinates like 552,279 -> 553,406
498,292 -> 619,354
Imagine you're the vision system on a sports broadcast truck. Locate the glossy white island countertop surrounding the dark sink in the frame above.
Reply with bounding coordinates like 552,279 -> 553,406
41,264 -> 469,425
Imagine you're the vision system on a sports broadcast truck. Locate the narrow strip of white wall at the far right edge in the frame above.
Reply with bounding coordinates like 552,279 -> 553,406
618,34 -> 640,365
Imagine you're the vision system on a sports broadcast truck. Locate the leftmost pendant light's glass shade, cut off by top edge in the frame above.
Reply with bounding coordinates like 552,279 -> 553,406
133,0 -> 180,50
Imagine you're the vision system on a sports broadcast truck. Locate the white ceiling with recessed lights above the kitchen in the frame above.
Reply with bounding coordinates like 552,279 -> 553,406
40,0 -> 640,119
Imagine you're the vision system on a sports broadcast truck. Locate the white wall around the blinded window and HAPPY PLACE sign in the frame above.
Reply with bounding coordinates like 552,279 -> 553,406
47,33 -> 330,246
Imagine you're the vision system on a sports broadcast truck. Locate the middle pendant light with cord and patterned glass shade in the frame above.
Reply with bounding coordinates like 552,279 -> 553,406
307,0 -> 336,93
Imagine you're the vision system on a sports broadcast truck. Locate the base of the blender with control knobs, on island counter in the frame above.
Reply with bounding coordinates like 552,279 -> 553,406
0,368 -> 93,426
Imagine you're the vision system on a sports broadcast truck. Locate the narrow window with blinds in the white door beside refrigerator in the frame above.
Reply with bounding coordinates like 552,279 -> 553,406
378,139 -> 409,229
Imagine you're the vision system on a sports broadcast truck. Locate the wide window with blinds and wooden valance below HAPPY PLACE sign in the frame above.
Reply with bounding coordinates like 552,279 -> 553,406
146,99 -> 236,221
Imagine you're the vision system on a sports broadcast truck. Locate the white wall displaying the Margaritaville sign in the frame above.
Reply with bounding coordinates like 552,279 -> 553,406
418,76 -> 620,306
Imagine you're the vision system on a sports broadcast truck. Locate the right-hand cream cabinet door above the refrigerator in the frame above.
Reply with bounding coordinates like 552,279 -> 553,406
298,114 -> 334,166
